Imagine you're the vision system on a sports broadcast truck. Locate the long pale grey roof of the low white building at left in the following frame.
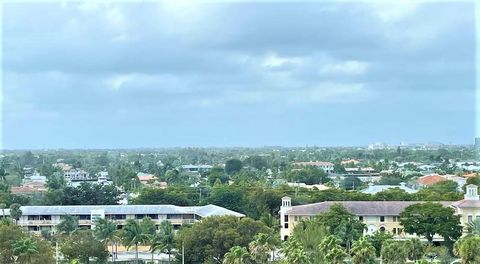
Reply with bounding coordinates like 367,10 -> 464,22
5,204 -> 245,217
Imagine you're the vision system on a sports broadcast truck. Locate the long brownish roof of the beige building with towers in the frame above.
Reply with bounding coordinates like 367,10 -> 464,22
286,201 -> 451,216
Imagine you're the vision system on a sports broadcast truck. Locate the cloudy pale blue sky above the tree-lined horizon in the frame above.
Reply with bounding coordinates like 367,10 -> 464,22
1,0 -> 475,149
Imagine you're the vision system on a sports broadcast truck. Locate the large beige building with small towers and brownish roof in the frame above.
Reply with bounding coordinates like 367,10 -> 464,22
280,184 -> 480,240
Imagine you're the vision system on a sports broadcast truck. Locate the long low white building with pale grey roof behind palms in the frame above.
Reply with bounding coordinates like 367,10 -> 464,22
5,204 -> 245,232
